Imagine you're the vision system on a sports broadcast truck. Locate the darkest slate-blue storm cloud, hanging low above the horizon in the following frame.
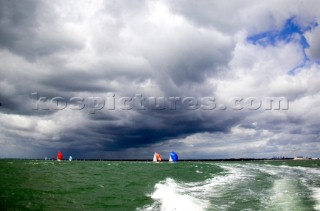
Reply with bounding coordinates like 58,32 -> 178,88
53,108 -> 239,152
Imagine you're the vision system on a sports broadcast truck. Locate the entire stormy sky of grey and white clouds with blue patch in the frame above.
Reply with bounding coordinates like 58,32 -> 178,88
0,0 -> 320,159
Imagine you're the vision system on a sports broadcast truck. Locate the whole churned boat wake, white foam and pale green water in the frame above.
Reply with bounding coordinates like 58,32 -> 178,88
137,163 -> 320,211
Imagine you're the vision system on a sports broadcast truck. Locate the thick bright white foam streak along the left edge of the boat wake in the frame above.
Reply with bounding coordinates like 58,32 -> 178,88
137,166 -> 250,211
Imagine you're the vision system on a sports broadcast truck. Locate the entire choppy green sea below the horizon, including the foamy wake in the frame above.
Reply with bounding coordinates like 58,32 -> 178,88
0,160 -> 320,211
